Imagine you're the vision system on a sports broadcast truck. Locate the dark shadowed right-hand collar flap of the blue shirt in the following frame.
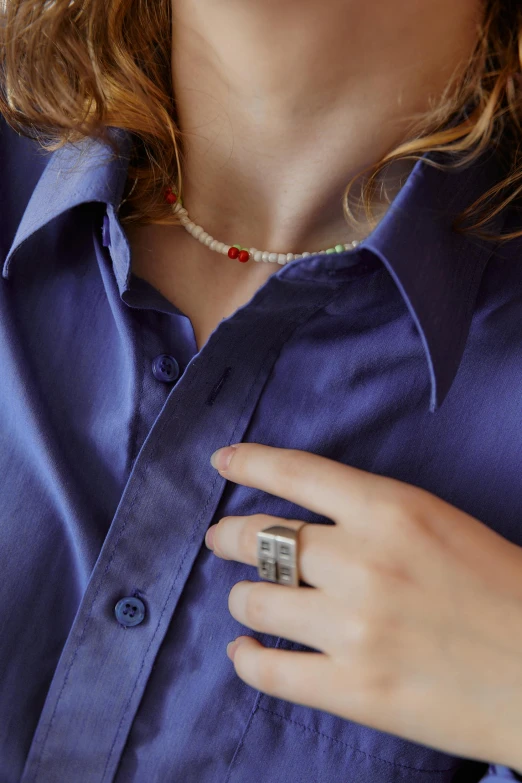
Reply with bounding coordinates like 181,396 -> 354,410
364,148 -> 506,413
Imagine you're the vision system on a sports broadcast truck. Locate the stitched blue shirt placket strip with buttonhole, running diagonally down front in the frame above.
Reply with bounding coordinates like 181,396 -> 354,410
21,262 -> 374,783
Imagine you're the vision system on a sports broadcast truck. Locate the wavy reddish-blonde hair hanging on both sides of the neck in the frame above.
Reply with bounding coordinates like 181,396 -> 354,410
0,0 -> 522,242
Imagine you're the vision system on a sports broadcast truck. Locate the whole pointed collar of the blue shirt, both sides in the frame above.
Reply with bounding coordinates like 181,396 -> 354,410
2,128 -> 505,412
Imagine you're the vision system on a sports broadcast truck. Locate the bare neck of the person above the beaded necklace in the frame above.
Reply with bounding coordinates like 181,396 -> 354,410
172,0 -> 481,253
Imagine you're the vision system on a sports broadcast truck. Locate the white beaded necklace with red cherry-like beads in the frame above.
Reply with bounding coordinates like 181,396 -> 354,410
165,187 -> 360,264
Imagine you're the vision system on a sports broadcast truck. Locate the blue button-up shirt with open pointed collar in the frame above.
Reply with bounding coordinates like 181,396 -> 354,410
0,118 -> 522,783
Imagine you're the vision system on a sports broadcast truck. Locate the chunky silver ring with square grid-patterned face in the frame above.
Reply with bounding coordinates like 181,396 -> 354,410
257,522 -> 306,587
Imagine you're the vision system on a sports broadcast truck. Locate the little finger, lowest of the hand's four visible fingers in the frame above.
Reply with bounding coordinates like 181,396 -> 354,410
230,636 -> 338,712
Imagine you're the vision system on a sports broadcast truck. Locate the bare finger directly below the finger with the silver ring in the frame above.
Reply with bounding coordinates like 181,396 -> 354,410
228,581 -> 348,655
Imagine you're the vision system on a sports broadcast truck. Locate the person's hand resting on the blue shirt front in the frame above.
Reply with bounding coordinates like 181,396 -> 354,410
207,443 -> 522,769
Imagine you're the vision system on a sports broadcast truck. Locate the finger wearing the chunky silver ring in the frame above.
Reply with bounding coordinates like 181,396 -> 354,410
210,514 -> 338,587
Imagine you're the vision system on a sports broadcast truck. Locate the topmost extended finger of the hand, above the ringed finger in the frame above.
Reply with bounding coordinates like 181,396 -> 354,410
209,443 -> 396,525
